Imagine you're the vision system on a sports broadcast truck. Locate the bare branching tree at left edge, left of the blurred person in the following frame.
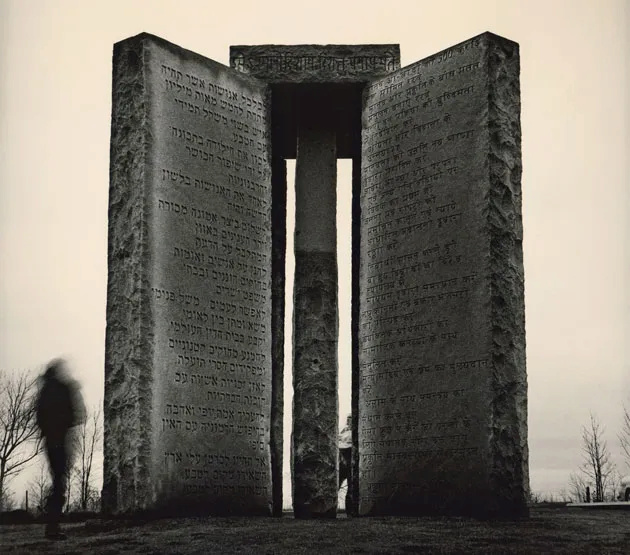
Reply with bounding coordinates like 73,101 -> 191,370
0,370 -> 39,510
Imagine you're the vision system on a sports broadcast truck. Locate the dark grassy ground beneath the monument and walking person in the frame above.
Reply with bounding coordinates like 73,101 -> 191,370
0,508 -> 630,555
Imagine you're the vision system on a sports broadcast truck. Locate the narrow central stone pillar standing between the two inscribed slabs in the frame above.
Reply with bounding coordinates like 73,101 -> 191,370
291,97 -> 339,518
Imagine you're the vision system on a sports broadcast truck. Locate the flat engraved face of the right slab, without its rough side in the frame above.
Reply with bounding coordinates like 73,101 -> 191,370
359,35 -> 522,514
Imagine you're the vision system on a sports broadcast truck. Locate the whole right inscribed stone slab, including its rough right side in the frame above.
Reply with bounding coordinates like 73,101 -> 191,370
358,33 -> 528,516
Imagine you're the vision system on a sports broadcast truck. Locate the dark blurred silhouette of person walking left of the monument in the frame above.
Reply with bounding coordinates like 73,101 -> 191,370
36,358 -> 85,540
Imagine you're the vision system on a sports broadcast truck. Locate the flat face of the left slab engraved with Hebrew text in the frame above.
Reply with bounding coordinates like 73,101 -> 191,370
105,35 -> 272,514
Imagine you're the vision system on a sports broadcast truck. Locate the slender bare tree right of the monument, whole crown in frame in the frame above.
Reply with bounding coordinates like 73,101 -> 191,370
582,414 -> 615,502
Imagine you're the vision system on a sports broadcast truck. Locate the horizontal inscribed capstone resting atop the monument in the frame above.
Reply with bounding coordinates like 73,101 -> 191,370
230,44 -> 400,83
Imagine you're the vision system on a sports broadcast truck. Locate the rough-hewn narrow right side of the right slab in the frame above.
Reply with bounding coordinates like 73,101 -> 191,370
485,33 -> 529,517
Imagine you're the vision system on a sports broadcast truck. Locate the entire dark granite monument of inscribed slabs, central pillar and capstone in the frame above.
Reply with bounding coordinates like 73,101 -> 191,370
103,33 -> 528,518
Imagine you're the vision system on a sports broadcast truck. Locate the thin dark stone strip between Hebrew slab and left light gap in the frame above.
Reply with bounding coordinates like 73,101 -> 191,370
270,158 -> 287,516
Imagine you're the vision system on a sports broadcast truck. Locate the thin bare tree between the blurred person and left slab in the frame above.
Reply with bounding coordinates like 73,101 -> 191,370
74,404 -> 103,511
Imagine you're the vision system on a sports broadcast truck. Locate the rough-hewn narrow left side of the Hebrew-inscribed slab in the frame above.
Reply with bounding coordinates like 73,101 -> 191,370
103,35 -> 153,513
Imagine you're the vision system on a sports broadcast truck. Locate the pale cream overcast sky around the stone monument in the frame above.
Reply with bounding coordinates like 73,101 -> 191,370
0,0 -> 630,504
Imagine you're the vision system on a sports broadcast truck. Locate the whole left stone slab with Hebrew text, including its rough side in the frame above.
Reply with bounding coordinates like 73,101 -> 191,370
103,34 -> 272,514
